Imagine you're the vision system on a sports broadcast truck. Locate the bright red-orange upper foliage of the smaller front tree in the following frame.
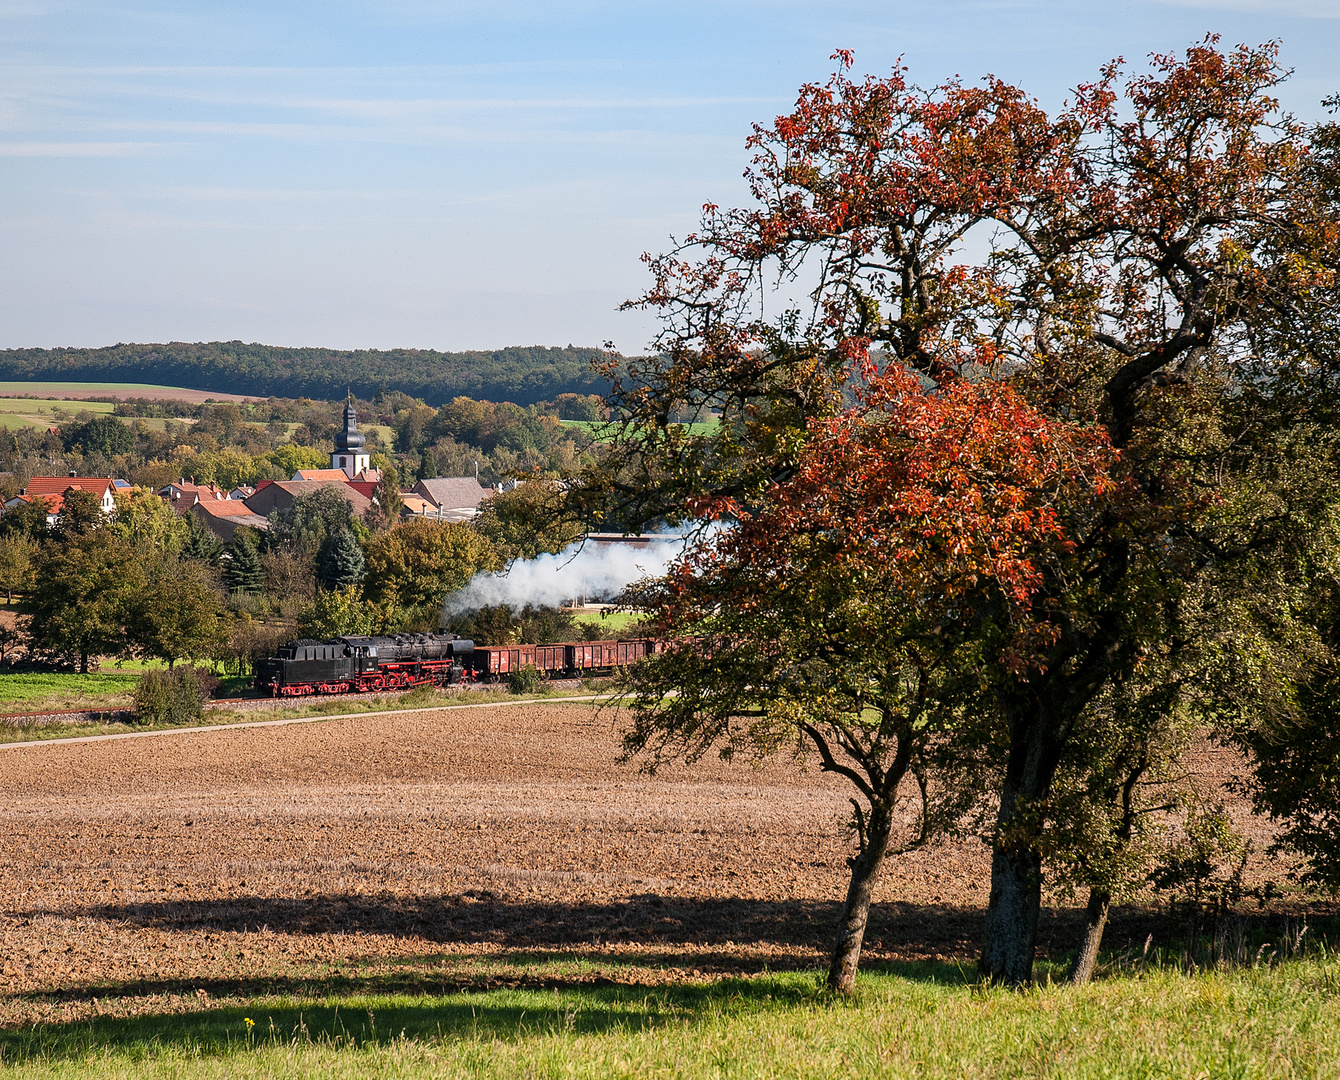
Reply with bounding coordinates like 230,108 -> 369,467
675,362 -> 1128,674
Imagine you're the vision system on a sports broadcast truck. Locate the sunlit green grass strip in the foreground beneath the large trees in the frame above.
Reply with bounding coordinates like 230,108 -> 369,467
0,957 -> 1340,1080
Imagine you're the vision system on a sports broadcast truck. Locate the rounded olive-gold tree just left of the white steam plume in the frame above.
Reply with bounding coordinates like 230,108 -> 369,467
364,519 -> 503,618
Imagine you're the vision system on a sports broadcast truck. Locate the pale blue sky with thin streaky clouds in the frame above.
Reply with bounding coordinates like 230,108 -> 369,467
0,0 -> 1340,352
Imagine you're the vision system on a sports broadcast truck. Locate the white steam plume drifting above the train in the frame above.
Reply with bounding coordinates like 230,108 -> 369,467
442,536 -> 685,618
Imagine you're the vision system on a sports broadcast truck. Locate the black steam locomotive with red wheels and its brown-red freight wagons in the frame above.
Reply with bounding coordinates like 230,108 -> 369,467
255,634 -> 667,697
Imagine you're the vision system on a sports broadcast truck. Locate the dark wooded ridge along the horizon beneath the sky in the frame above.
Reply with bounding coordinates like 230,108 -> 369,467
0,342 -> 608,405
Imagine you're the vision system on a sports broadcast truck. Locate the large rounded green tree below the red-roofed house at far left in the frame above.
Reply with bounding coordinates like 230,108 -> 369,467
19,529 -> 145,673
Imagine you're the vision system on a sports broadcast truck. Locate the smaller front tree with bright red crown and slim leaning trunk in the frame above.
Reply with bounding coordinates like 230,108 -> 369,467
624,364 -> 1120,990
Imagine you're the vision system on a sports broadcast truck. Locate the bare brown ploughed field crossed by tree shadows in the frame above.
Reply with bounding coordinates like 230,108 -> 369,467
0,703 -> 1318,1025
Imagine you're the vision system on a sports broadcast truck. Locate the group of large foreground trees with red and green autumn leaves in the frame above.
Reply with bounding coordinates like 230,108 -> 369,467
571,38 -> 1340,990
